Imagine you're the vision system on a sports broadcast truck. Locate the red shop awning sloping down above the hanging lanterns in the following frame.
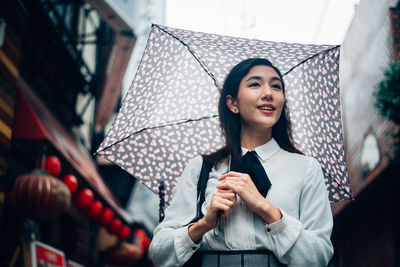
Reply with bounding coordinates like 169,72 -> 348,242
13,79 -> 132,223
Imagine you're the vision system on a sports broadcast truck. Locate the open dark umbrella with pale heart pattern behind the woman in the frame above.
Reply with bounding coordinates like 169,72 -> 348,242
97,24 -> 352,203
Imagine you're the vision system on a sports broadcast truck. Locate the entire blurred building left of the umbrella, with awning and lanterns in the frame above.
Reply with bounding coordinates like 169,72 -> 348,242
0,0 -> 162,266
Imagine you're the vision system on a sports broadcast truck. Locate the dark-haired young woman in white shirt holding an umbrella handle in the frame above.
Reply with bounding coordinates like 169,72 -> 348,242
150,58 -> 333,266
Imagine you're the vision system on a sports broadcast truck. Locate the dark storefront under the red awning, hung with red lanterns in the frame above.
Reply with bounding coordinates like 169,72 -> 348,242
5,77 -> 149,266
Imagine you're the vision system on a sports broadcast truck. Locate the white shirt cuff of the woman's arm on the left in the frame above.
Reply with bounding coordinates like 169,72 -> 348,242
174,224 -> 201,265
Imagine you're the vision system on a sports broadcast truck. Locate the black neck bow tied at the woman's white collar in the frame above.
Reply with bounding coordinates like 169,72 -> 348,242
238,151 -> 271,197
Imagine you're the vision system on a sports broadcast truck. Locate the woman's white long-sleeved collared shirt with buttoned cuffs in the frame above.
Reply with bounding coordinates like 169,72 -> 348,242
150,139 -> 333,266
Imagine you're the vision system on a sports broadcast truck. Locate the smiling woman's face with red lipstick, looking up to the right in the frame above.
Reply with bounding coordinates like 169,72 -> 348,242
227,65 -> 285,133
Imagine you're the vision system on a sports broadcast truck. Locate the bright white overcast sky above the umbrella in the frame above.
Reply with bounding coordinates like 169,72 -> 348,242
165,0 -> 358,44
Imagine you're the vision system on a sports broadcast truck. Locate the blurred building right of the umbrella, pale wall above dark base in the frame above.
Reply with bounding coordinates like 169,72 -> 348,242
332,0 -> 400,266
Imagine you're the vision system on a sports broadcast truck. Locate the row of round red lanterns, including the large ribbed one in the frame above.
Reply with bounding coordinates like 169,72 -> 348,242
11,155 -> 132,243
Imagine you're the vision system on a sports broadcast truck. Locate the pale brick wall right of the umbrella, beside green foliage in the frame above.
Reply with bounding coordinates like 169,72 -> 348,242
333,0 -> 394,214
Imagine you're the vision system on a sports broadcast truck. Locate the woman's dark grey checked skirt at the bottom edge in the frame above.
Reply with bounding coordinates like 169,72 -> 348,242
201,250 -> 286,267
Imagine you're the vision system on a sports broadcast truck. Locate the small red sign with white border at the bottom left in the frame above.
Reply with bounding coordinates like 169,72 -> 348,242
31,241 -> 65,267
